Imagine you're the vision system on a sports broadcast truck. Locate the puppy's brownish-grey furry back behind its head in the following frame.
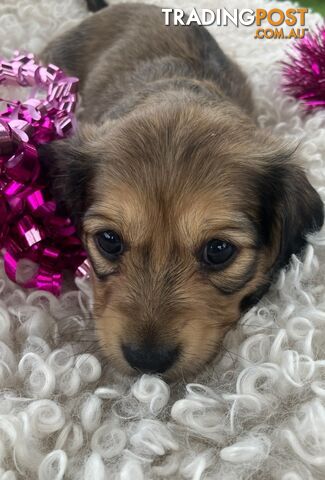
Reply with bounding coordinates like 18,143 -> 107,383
41,4 -> 252,121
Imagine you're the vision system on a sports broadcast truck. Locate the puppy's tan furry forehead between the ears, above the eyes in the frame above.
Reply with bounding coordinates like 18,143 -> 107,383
88,106 -> 260,242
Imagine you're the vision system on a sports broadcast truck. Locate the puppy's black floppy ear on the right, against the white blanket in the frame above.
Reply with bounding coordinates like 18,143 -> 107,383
259,156 -> 324,269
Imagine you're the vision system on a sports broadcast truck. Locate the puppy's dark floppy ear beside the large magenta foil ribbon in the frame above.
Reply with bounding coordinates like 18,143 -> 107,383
38,128 -> 96,227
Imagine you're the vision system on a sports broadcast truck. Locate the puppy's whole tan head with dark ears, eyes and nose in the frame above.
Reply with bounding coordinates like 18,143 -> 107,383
41,102 -> 323,378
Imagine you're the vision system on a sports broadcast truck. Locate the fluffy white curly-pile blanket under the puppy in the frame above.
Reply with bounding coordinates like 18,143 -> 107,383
0,0 -> 325,480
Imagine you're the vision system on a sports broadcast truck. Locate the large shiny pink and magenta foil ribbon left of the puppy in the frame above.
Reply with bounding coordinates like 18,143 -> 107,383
0,52 -> 89,295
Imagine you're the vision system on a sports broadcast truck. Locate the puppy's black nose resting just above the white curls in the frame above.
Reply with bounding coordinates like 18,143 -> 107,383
122,345 -> 179,373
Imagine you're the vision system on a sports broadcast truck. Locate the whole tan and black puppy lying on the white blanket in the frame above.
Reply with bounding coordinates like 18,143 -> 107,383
40,2 -> 324,379
